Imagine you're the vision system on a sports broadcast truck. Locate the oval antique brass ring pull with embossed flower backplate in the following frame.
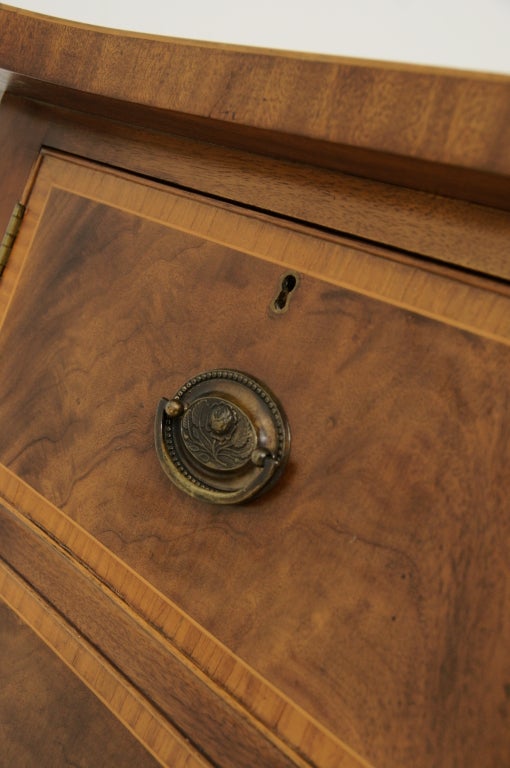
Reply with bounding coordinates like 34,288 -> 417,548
155,369 -> 290,504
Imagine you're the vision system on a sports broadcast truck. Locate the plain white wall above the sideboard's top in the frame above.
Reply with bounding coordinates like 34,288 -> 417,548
10,0 -> 510,74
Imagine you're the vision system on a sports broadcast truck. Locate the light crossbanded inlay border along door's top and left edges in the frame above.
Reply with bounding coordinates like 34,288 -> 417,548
0,154 -> 510,344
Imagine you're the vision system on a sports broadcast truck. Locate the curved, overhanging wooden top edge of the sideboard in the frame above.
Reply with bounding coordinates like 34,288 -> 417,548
0,4 -> 510,205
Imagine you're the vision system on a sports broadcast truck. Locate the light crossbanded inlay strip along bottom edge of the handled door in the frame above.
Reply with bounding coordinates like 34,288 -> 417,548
0,465 -> 369,768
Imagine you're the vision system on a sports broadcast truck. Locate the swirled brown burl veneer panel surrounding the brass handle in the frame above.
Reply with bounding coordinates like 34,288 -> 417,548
0,159 -> 510,768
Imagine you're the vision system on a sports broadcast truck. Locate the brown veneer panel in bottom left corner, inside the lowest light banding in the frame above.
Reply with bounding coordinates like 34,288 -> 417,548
0,600 -> 167,768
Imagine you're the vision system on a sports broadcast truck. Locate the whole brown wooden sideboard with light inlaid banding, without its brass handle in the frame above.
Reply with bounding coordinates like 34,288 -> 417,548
0,4 -> 510,768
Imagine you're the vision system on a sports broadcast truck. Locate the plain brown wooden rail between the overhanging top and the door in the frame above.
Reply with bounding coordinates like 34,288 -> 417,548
0,95 -> 510,279
